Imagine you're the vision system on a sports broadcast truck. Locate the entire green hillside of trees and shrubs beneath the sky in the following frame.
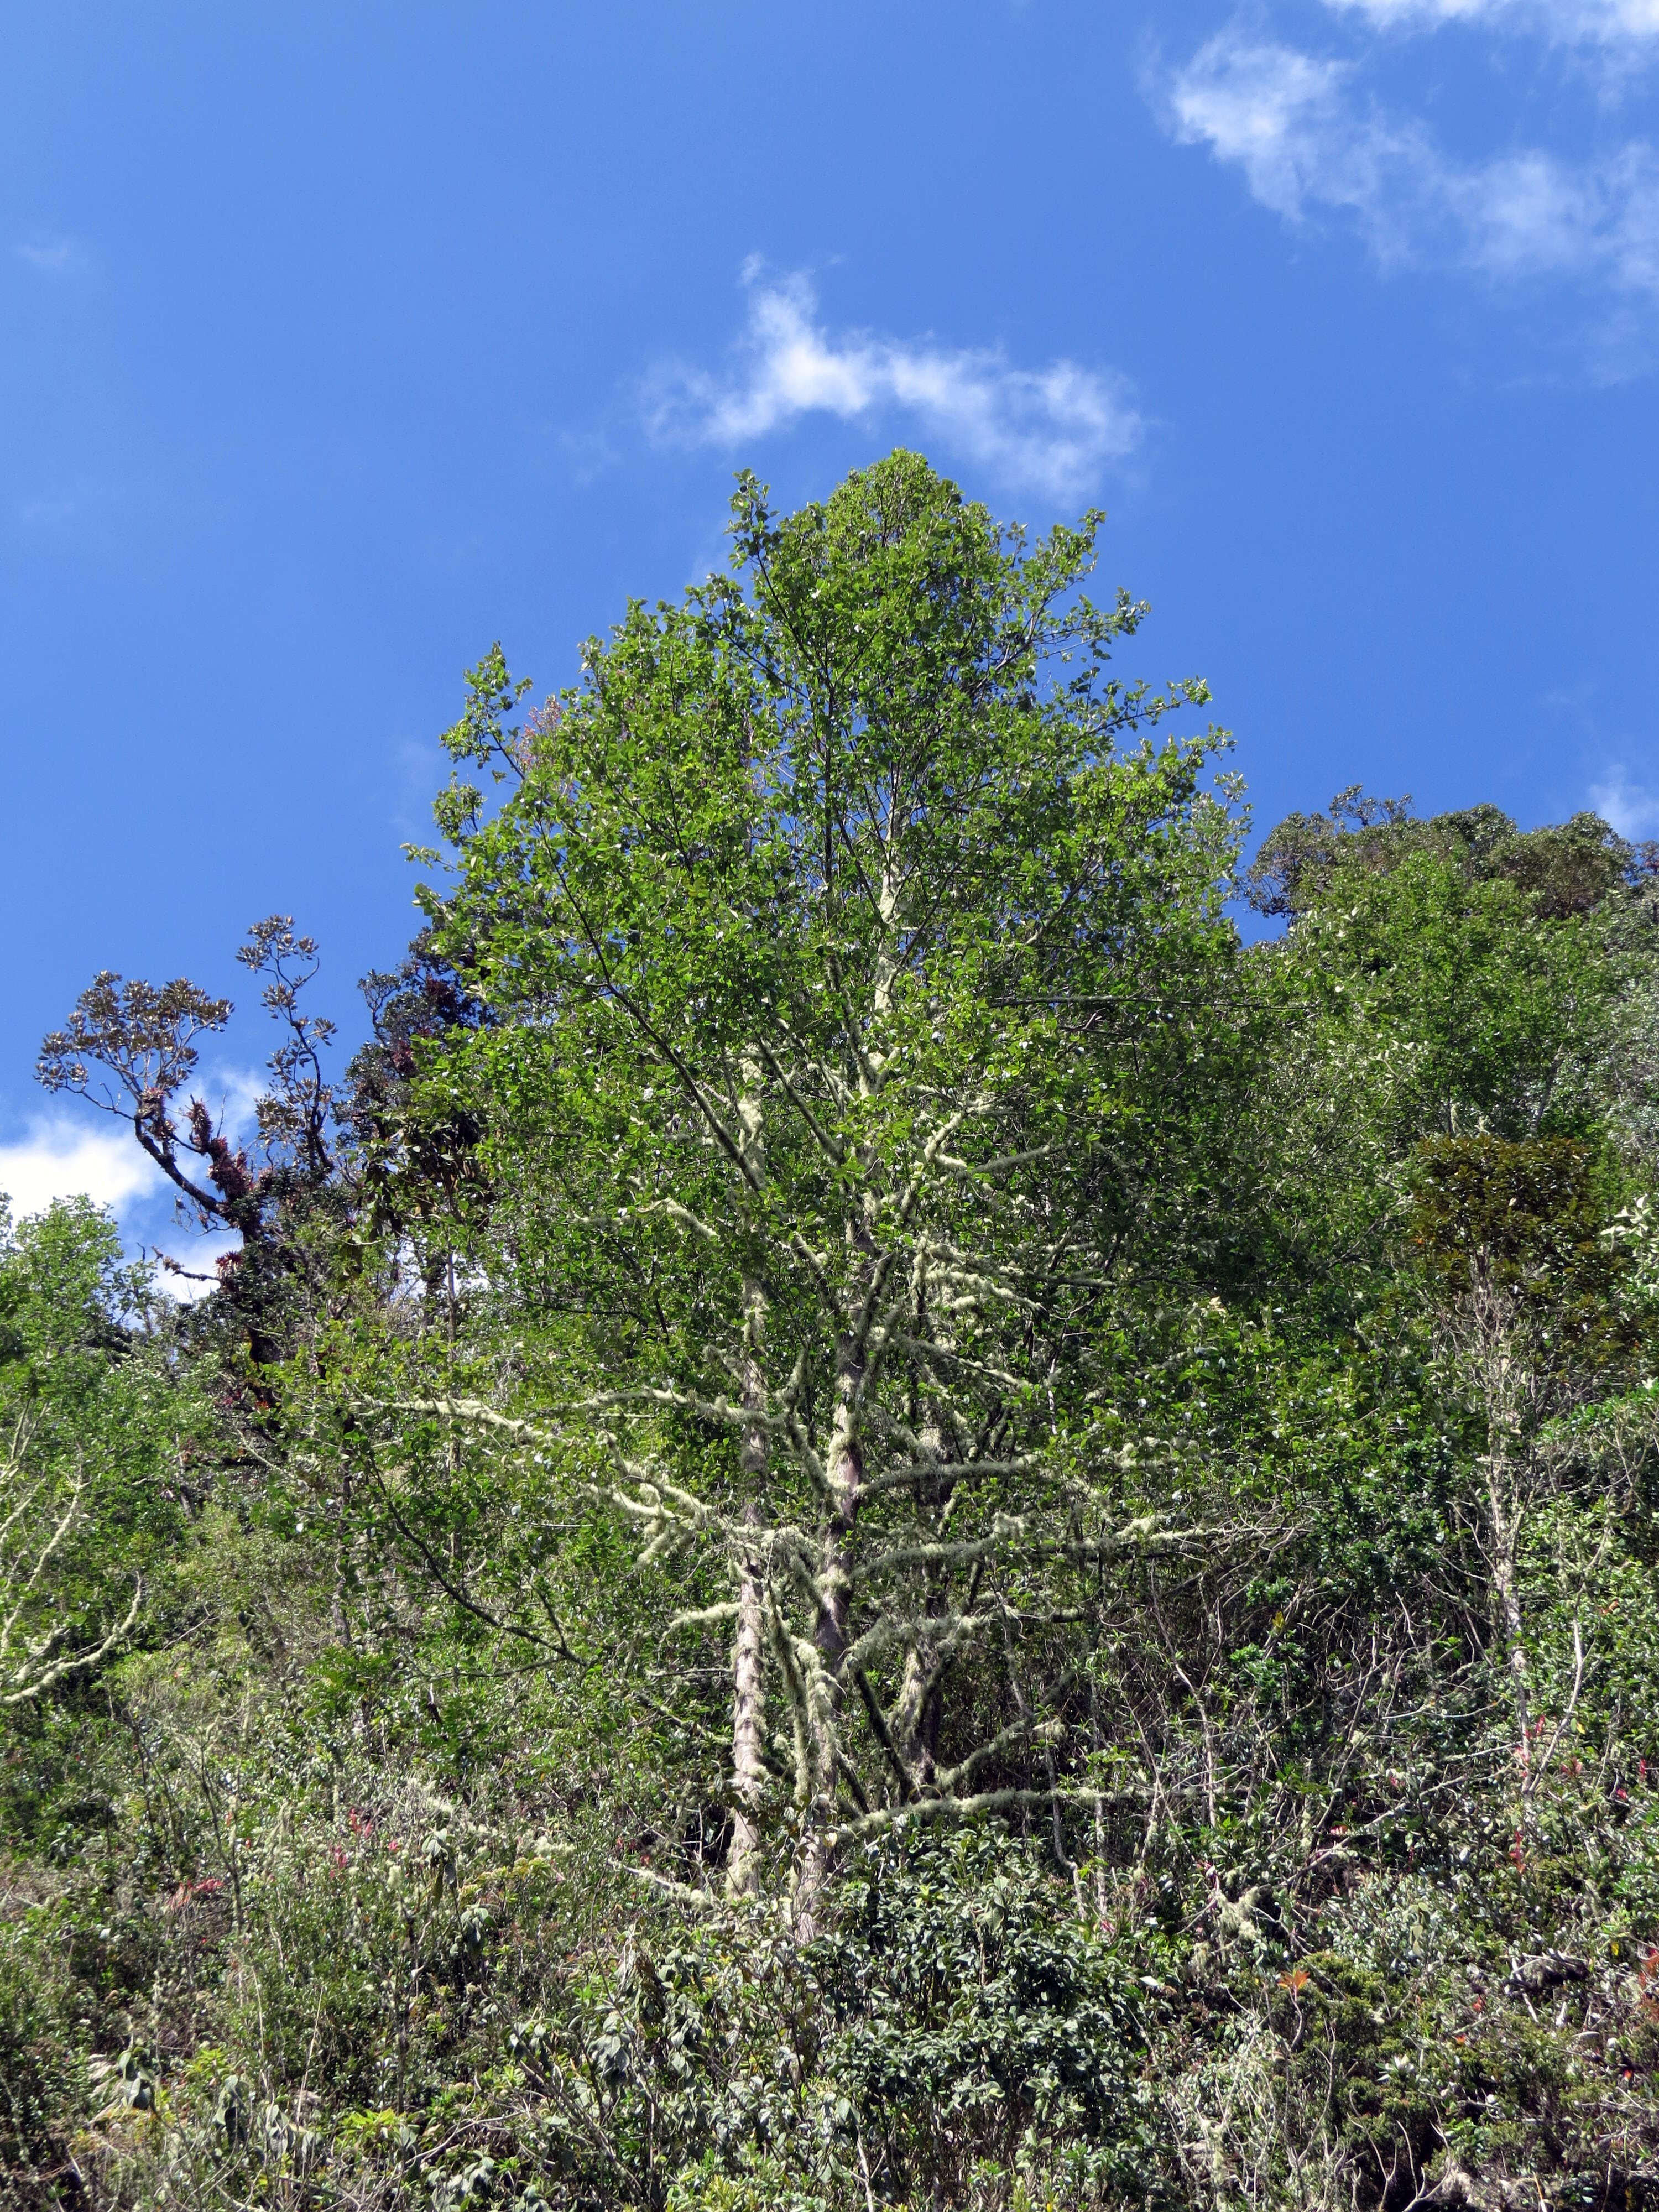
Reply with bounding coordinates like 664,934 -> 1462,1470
0,453 -> 1659,2212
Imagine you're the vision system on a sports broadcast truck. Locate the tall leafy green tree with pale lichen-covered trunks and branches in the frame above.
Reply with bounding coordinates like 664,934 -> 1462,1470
396,453 -> 1237,1920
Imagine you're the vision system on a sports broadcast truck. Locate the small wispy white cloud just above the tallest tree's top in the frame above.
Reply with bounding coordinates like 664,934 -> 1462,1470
646,263 -> 1141,500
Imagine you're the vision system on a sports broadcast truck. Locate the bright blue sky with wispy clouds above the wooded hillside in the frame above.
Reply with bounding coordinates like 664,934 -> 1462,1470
0,0 -> 1659,1274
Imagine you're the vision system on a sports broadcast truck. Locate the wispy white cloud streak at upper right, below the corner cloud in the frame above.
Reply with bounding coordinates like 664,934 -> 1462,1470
1166,33 -> 1659,296
